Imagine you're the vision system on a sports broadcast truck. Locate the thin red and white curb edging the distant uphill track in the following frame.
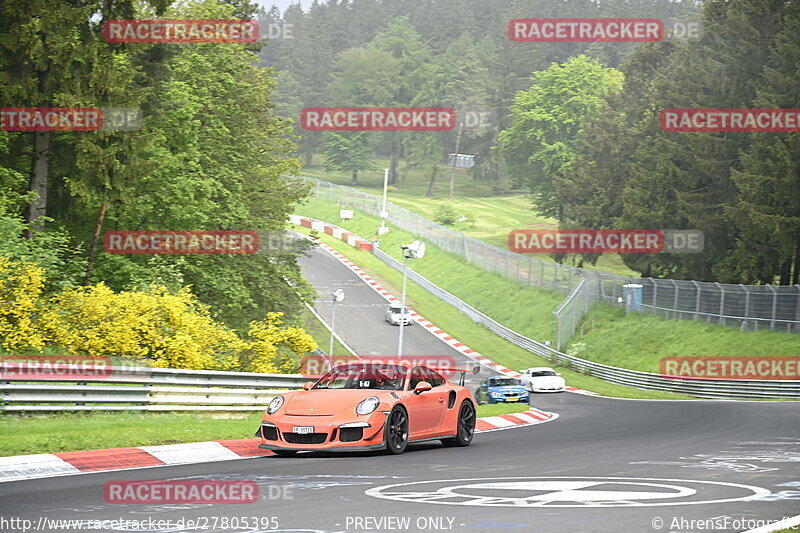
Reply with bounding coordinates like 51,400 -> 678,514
290,215 -> 594,395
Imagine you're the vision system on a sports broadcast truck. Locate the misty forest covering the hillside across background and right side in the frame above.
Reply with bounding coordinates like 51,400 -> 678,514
259,0 -> 800,284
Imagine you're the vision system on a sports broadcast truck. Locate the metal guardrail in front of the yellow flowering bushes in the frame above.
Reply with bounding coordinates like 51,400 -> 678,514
0,366 -> 307,412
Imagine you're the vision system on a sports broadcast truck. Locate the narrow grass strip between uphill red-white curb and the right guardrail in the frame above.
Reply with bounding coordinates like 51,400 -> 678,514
296,221 -> 689,399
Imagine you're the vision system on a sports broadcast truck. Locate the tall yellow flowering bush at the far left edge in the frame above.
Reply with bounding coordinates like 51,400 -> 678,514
0,257 -> 46,350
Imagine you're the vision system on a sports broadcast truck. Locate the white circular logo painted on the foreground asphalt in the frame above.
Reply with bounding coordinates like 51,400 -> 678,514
365,476 -> 771,508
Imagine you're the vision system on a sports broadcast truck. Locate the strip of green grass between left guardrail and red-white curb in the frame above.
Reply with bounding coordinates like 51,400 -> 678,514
0,412 -> 263,456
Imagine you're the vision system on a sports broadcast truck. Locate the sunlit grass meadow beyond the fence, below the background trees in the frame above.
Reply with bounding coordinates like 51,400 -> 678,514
302,157 -> 637,276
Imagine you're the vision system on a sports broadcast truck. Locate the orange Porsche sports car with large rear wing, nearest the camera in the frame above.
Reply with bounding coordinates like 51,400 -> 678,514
256,360 -> 479,455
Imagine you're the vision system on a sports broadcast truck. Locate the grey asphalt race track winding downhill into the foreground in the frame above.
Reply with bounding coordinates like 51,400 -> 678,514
0,243 -> 800,533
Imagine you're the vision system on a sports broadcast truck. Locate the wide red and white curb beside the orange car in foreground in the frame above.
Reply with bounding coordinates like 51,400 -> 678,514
0,409 -> 558,482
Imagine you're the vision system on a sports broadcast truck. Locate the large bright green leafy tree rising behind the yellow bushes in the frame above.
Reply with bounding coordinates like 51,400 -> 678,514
86,1 -> 311,327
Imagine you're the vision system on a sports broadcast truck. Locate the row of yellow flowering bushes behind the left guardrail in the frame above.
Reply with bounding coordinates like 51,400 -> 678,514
0,257 -> 317,372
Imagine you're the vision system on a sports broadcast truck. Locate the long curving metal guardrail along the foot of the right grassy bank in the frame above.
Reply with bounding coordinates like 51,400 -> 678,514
373,248 -> 800,399
